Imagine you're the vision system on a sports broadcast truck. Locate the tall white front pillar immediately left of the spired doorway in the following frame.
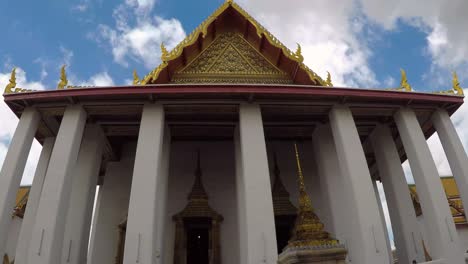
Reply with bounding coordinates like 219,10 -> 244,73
124,104 -> 170,264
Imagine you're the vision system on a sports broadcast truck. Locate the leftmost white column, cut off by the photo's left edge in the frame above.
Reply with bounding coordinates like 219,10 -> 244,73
0,108 -> 40,256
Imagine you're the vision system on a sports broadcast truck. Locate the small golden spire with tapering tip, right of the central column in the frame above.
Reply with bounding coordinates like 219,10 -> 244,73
287,143 -> 339,248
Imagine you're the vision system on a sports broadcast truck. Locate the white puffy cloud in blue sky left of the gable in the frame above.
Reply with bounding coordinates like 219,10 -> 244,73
97,0 -> 186,69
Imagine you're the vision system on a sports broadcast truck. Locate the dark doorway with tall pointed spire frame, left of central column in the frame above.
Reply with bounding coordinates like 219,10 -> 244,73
173,154 -> 223,264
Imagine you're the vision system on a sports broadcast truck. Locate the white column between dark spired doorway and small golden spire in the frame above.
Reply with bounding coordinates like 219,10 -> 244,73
236,104 -> 278,264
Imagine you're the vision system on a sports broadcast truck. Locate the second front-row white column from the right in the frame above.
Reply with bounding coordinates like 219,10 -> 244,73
394,108 -> 465,264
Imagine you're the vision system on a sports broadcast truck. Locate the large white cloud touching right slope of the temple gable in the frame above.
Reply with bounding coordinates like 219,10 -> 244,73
239,0 -> 377,87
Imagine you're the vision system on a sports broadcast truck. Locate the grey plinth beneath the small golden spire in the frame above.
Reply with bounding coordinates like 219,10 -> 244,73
278,245 -> 348,264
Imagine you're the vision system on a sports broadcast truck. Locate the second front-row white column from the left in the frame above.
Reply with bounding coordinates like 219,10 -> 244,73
28,105 -> 86,264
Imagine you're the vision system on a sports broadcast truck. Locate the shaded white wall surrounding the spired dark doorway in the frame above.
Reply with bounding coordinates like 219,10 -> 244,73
164,141 -> 239,264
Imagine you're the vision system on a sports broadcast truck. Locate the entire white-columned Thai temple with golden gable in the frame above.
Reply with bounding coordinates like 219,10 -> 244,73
0,0 -> 468,264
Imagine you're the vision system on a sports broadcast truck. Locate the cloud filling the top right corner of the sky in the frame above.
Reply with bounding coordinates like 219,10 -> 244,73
361,0 -> 468,72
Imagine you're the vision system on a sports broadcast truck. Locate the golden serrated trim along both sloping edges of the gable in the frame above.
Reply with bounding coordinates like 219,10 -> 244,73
141,0 -> 330,86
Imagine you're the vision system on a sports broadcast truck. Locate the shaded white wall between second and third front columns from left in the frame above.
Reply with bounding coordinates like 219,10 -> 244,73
90,143 -> 136,264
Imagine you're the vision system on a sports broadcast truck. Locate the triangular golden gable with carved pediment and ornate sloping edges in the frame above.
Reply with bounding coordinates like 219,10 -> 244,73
139,0 -> 332,86
